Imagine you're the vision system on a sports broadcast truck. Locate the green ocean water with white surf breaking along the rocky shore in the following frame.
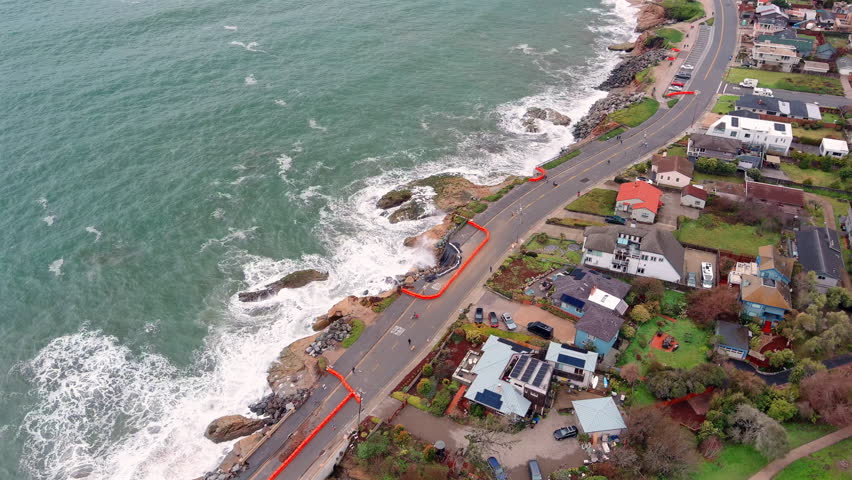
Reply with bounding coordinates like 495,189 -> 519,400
0,0 -> 634,480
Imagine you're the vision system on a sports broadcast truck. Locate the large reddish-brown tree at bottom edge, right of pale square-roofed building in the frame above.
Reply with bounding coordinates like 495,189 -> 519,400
614,407 -> 698,478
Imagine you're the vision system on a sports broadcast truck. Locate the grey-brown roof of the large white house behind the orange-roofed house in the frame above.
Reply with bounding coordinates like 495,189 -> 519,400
583,225 -> 684,275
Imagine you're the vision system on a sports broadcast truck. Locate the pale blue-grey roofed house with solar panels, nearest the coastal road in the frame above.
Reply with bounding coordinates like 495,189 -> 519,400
462,335 -> 553,417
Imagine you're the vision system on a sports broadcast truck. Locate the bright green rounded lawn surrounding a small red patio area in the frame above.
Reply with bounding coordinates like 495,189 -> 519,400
619,317 -> 710,374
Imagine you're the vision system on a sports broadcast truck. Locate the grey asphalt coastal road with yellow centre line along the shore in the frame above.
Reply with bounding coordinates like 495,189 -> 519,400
233,0 -> 737,480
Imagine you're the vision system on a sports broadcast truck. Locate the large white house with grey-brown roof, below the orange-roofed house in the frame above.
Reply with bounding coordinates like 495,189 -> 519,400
575,225 -> 684,284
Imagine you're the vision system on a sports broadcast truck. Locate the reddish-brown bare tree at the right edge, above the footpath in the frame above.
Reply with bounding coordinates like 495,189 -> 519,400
800,366 -> 852,427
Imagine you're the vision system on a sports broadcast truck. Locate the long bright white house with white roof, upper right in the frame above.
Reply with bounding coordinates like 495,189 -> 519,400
707,115 -> 793,155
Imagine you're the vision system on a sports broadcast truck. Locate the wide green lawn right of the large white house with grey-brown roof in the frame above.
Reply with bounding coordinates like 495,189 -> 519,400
674,215 -> 781,255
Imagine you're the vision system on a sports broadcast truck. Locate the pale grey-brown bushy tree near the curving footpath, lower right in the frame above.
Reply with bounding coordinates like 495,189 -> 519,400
728,404 -> 790,460
